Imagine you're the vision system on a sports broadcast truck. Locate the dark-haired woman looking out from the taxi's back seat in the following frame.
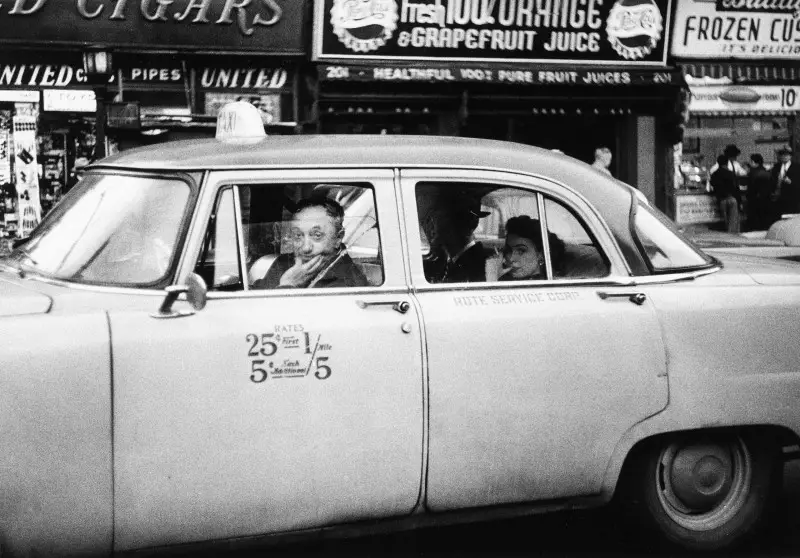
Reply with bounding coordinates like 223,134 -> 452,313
498,215 -> 564,281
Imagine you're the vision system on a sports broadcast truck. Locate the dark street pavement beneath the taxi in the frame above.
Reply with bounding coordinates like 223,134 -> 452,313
188,461 -> 800,558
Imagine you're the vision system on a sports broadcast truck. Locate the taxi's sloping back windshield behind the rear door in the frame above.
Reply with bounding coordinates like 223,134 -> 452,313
634,203 -> 713,272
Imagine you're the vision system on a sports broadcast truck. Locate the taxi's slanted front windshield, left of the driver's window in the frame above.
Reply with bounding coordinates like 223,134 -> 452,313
9,174 -> 191,287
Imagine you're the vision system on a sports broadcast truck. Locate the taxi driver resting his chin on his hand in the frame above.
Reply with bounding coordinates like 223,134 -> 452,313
253,198 -> 368,289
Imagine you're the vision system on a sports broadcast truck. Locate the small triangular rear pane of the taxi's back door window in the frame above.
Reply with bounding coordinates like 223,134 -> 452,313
544,198 -> 610,279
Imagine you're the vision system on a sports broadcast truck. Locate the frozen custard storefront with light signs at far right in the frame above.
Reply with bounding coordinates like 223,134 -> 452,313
671,0 -> 800,228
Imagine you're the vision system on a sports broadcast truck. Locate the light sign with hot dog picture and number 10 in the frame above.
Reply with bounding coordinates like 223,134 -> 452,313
689,85 -> 800,113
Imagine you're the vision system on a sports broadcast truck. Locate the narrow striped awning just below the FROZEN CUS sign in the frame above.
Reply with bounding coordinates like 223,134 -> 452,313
679,62 -> 800,85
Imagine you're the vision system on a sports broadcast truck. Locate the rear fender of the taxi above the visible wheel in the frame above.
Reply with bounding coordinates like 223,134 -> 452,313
603,282 -> 800,500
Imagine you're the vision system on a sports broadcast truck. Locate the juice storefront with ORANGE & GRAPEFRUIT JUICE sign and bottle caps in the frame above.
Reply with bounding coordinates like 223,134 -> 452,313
313,0 -> 682,214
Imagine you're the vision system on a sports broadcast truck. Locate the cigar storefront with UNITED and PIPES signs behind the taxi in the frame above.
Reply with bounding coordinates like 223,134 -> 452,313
0,0 -> 308,245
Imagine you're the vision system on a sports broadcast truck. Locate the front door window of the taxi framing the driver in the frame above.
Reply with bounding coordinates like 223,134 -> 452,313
197,183 -> 384,290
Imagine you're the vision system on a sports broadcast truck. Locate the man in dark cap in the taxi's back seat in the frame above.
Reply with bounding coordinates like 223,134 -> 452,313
424,194 -> 489,283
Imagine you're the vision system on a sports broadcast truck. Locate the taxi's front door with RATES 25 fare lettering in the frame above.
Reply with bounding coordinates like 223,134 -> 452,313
110,170 -> 423,550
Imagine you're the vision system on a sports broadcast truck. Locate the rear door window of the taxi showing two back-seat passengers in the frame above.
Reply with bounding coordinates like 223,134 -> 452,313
416,182 -> 610,284
